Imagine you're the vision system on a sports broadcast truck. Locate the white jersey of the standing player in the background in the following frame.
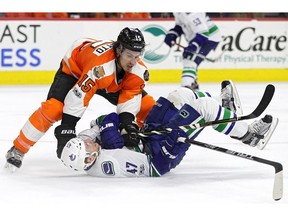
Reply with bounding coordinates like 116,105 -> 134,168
173,13 -> 222,42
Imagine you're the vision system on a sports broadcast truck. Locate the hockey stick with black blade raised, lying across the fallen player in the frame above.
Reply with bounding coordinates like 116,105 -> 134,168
142,84 -> 275,137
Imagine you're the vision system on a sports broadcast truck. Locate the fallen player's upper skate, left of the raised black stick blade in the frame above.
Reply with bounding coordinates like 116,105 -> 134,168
221,80 -> 243,115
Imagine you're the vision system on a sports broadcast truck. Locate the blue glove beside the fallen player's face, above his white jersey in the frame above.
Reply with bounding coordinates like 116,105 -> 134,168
96,113 -> 124,149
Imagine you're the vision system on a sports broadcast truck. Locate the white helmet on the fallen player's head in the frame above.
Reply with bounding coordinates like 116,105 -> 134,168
61,137 -> 96,171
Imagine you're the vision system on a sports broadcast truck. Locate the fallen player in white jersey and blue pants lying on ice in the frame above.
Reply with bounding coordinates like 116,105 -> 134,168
61,82 -> 278,177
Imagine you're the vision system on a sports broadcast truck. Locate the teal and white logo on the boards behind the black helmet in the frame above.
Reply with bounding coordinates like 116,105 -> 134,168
141,25 -> 171,64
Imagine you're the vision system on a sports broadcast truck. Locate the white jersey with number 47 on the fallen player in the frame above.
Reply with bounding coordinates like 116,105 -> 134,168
87,147 -> 150,177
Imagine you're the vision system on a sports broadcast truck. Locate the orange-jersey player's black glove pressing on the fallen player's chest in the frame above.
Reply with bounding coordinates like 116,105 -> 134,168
119,122 -> 140,147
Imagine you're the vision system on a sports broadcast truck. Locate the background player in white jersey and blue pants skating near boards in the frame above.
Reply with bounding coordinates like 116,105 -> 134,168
164,12 -> 222,90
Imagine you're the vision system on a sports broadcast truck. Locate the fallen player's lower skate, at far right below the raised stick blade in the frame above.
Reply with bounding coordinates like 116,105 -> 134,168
241,115 -> 279,150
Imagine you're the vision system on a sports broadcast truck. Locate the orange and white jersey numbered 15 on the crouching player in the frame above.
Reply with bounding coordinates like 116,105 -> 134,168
62,38 -> 148,118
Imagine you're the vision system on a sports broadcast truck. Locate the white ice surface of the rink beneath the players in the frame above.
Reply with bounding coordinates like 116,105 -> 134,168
0,82 -> 288,216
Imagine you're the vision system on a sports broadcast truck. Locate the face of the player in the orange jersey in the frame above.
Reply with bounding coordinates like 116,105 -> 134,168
119,49 -> 141,71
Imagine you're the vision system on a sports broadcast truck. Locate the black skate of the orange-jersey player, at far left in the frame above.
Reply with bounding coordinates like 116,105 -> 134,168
5,146 -> 24,172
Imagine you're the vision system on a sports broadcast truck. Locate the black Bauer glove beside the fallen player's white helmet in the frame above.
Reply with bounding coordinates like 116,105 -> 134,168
54,125 -> 76,159
